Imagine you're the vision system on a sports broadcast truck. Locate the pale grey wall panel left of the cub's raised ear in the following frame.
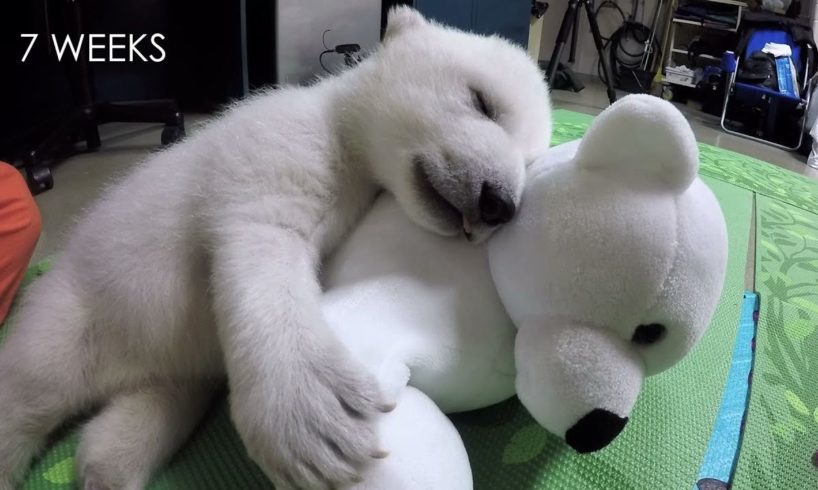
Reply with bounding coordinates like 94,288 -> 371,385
276,0 -> 381,84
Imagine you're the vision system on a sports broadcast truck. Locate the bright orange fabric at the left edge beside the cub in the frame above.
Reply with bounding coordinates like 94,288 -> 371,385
0,162 -> 42,323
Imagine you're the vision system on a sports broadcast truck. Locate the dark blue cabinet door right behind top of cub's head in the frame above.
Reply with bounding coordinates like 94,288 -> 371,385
415,0 -> 531,46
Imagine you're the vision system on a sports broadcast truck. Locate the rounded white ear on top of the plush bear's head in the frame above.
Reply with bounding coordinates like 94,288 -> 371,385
576,94 -> 699,192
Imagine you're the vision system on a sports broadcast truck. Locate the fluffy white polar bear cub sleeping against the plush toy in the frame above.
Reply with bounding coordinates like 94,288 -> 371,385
0,8 -> 550,490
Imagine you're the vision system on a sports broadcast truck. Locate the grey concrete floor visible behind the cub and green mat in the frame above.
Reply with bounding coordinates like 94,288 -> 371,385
28,81 -> 818,280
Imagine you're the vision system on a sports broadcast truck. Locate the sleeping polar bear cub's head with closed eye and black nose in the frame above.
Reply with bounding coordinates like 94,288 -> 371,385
359,7 -> 551,242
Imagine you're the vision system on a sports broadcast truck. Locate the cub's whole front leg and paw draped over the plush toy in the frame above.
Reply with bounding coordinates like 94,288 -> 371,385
212,224 -> 387,488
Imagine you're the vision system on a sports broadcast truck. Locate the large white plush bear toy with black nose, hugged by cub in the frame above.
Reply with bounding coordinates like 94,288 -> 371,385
324,95 -> 727,490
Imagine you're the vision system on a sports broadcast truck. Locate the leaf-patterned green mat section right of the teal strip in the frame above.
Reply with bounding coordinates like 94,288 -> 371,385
735,196 -> 818,489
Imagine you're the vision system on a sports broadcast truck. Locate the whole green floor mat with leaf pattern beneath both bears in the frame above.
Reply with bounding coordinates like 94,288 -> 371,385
0,110 -> 818,490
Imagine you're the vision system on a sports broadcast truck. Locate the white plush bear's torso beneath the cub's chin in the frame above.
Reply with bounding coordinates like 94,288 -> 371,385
323,196 -> 515,411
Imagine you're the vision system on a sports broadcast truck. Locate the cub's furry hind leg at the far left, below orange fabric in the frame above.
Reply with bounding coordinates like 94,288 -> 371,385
0,269 -> 102,490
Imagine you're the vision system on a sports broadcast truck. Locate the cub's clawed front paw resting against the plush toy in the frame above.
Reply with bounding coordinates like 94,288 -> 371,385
232,353 -> 394,489
